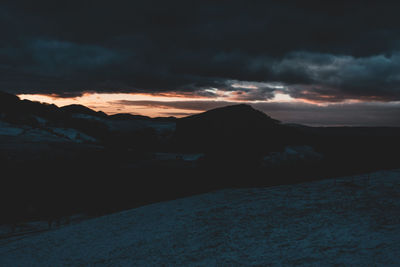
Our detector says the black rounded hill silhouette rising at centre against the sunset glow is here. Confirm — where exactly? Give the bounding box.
[176,104,287,153]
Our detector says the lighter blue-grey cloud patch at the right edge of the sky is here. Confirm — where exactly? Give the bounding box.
[275,52,400,101]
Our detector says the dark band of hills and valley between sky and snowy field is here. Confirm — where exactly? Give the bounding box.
[0,90,400,226]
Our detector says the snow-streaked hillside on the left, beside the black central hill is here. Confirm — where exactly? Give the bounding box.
[0,91,175,146]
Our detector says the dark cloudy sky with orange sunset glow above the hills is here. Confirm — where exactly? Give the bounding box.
[0,0,400,126]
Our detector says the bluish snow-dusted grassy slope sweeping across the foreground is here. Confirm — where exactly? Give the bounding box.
[0,170,400,266]
